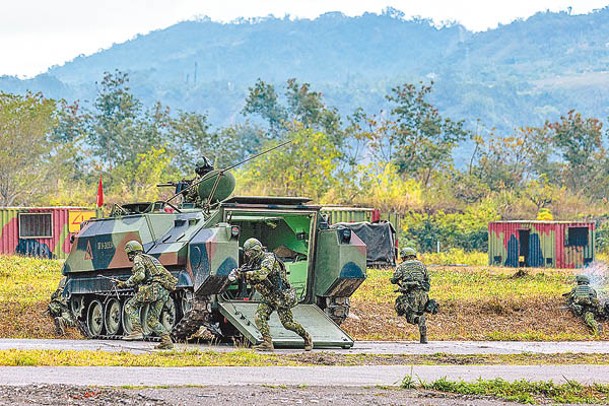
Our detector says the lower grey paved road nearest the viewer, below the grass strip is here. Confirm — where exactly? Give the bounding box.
[0,365,609,386]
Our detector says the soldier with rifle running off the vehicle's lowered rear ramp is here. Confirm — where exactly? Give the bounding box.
[229,238,313,351]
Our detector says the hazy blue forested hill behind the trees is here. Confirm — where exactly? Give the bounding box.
[0,8,609,131]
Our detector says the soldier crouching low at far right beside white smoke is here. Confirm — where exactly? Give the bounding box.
[563,275,604,335]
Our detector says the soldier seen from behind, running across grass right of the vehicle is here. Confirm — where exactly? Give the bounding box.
[391,248,435,344]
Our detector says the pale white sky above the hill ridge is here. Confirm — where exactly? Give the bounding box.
[0,0,609,77]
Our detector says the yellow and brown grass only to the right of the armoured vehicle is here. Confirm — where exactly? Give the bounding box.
[343,266,607,341]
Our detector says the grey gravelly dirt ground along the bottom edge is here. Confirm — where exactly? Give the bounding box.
[0,385,514,406]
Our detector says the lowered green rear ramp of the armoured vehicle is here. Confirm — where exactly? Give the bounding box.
[219,302,353,348]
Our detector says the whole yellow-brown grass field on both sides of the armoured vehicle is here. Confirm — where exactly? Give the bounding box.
[0,256,607,341]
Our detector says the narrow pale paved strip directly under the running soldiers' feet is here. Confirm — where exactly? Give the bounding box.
[0,339,609,354]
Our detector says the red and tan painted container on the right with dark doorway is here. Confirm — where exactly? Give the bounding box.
[488,220,595,268]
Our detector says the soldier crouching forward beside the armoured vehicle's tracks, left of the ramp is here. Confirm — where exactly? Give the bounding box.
[116,240,177,350]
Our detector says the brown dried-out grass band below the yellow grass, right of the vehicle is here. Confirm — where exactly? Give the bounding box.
[342,297,607,341]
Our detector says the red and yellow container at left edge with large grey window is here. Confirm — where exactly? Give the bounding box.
[0,207,102,259]
